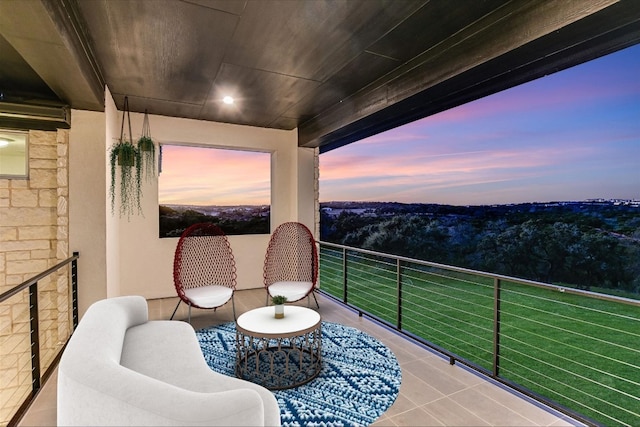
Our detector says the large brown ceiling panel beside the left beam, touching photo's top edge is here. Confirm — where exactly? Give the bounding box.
[79,0,238,104]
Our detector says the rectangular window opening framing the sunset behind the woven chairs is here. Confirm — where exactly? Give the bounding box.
[158,144,271,237]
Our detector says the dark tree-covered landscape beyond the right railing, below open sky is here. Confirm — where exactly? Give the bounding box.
[321,204,640,294]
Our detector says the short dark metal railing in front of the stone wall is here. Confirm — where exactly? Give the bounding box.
[0,252,80,426]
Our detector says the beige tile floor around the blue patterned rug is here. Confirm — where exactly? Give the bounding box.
[18,289,581,426]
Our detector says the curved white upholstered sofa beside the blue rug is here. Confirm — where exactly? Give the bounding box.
[57,296,280,426]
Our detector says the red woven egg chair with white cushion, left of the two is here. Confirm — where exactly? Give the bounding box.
[171,223,237,323]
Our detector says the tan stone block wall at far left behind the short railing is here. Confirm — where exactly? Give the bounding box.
[0,130,71,425]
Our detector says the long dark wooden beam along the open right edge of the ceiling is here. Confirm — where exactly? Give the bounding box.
[298,0,640,152]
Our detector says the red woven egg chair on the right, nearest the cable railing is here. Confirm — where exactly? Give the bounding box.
[264,222,320,308]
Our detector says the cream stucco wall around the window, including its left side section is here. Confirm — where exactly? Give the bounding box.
[70,91,317,314]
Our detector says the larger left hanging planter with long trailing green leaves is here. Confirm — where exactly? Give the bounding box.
[109,96,142,217]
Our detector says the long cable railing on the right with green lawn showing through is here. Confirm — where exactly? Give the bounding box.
[319,242,640,425]
